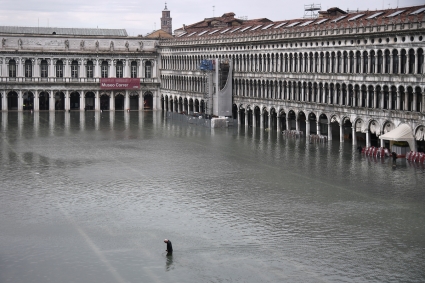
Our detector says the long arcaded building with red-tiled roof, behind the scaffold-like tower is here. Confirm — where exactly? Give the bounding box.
[159,6,425,150]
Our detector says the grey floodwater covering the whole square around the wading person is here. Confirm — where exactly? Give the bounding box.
[0,112,425,283]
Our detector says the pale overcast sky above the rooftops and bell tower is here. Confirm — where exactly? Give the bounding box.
[0,0,425,36]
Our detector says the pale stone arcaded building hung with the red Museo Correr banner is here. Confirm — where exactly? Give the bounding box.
[0,27,160,111]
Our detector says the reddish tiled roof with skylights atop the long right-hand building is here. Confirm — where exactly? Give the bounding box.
[170,5,425,40]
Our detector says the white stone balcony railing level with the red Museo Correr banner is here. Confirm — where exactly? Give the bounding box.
[0,77,159,84]
